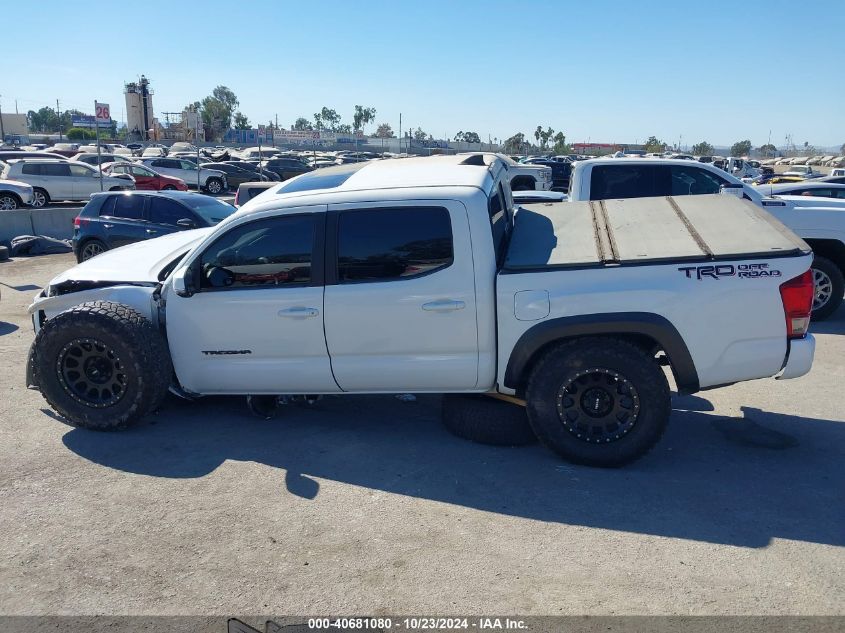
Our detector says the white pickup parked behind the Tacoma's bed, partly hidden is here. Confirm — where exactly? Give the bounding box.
[568,158,845,321]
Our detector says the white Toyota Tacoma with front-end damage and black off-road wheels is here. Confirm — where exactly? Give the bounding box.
[27,156,815,466]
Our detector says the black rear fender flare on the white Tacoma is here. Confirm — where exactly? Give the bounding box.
[504,312,700,393]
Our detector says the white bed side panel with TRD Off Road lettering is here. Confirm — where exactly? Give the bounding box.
[497,255,812,393]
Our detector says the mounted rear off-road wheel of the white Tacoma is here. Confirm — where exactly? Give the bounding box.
[526,337,671,467]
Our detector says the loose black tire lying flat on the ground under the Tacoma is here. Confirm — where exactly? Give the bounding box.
[442,394,537,446]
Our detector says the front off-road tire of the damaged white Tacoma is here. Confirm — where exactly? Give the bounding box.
[33,301,173,431]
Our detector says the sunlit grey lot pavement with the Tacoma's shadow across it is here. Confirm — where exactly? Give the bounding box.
[0,255,845,615]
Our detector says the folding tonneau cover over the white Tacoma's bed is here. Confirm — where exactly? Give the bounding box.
[504,194,810,270]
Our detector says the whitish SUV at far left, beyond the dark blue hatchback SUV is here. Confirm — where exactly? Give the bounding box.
[2,159,135,208]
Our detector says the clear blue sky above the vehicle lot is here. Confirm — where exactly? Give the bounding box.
[0,0,845,148]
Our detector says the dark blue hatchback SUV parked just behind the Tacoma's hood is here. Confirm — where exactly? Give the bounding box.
[73,191,235,262]
